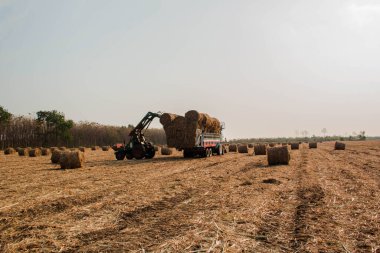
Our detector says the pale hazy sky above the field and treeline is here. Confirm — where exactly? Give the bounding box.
[0,0,380,139]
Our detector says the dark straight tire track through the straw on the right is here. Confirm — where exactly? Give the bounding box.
[291,148,343,252]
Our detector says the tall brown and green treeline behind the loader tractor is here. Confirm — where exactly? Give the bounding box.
[0,106,166,149]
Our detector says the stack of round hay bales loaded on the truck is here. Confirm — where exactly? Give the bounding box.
[160,110,221,148]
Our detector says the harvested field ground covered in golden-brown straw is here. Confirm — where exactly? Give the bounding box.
[0,141,380,253]
